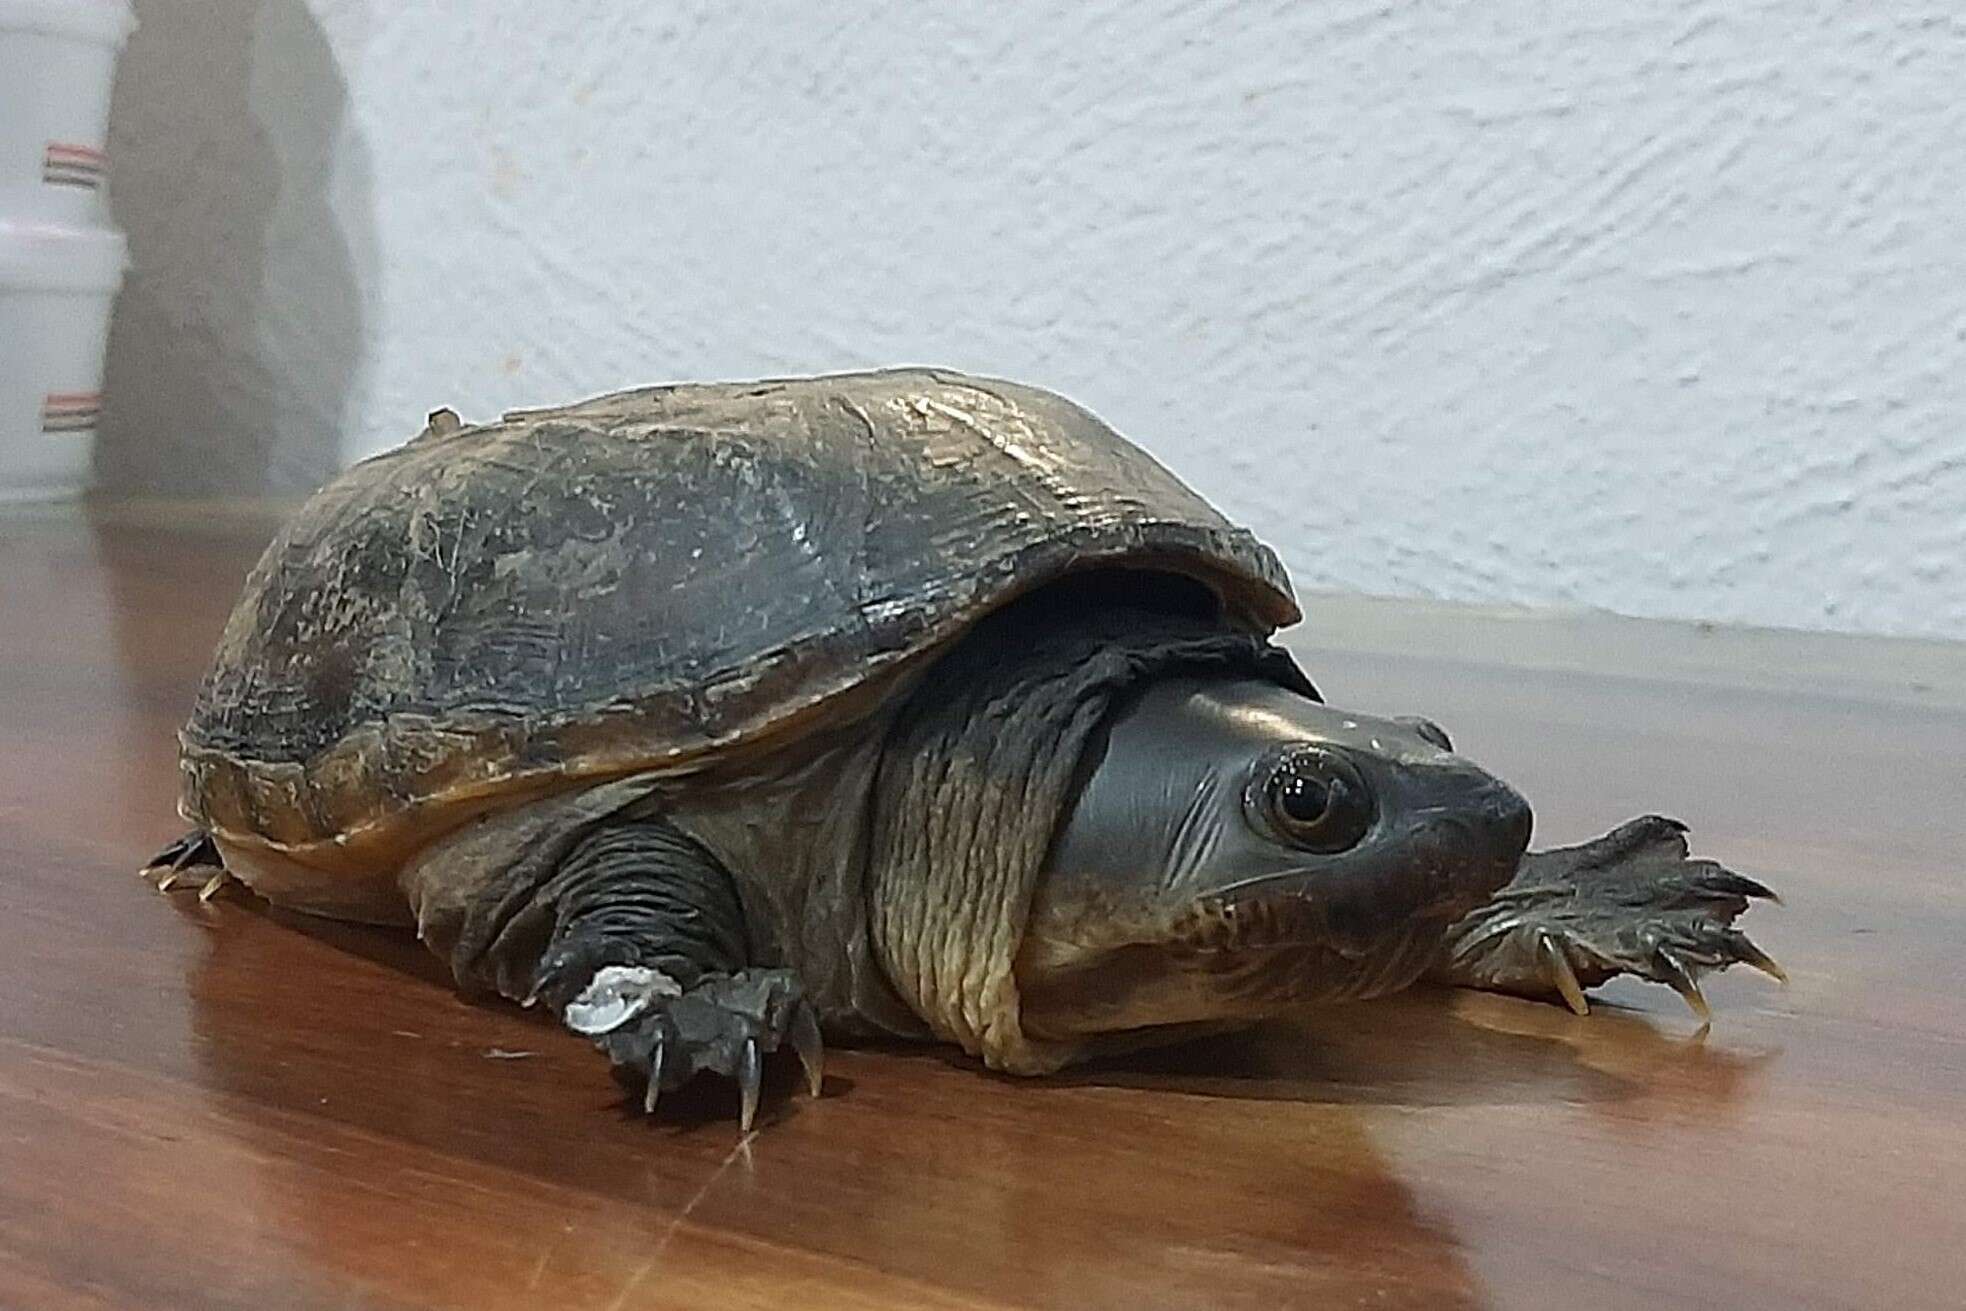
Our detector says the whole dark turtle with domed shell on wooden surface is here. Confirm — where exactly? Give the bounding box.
[144,368,1781,1132]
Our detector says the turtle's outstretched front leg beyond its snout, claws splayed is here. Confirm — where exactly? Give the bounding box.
[1429,816,1787,1022]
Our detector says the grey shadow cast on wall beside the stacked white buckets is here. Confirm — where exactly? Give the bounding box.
[96,0,374,495]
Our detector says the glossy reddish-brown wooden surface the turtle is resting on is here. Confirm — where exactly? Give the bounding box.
[0,511,1966,1309]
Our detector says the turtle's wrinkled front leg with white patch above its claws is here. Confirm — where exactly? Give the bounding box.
[490,820,822,1132]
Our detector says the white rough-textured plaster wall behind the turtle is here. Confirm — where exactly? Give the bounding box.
[104,0,1966,637]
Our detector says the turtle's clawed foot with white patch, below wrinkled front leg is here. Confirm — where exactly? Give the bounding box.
[560,965,824,1132]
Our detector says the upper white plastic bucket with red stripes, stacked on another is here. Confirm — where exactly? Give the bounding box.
[0,0,136,226]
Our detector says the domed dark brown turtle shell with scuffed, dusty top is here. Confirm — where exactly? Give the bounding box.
[181,370,1298,869]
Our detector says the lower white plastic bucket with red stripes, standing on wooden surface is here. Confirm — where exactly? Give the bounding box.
[0,220,126,501]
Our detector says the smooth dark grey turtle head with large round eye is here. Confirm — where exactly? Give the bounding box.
[1016,678,1530,1044]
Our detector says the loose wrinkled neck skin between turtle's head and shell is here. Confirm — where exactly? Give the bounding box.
[867,592,1309,1073]
